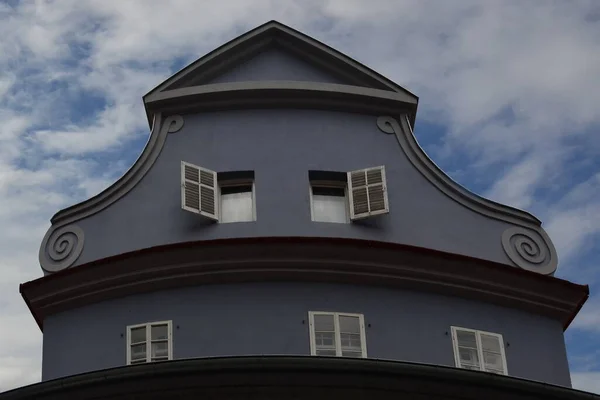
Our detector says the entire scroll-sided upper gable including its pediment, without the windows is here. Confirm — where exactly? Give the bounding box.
[40,23,557,282]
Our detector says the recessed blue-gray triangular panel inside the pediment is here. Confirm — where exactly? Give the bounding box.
[206,45,352,85]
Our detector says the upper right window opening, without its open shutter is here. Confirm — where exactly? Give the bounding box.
[310,182,350,223]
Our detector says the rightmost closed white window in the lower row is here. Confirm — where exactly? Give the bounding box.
[452,326,507,375]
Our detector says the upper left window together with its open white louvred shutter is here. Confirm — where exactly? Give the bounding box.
[181,162,256,223]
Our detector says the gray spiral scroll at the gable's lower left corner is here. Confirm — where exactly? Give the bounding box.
[40,225,84,272]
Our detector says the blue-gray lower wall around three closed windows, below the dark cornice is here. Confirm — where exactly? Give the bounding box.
[42,282,570,386]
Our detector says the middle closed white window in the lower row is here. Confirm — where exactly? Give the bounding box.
[308,311,367,358]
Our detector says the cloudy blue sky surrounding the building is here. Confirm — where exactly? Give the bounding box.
[0,0,600,393]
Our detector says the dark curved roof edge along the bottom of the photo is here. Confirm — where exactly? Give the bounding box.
[0,356,600,400]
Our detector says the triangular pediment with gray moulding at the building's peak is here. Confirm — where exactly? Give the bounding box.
[144,21,416,102]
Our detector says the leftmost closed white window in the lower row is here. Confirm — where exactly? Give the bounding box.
[127,321,173,365]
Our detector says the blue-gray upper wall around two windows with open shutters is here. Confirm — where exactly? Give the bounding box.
[75,109,512,265]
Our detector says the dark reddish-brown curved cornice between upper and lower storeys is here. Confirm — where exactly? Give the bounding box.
[20,237,589,329]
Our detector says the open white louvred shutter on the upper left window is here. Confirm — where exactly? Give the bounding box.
[181,161,219,221]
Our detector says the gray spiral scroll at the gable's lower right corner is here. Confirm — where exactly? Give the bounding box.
[502,226,558,275]
